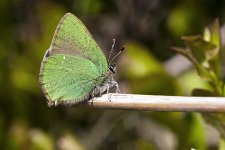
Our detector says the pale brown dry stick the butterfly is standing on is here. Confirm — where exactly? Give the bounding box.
[87,93,225,112]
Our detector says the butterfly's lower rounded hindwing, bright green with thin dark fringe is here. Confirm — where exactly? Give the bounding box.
[42,54,103,105]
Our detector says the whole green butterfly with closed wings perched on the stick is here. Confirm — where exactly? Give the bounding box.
[39,13,119,106]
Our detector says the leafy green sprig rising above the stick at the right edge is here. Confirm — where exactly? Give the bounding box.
[172,19,224,96]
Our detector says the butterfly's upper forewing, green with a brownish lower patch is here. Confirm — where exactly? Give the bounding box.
[50,13,108,74]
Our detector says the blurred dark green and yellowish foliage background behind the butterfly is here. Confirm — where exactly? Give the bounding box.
[0,0,225,150]
